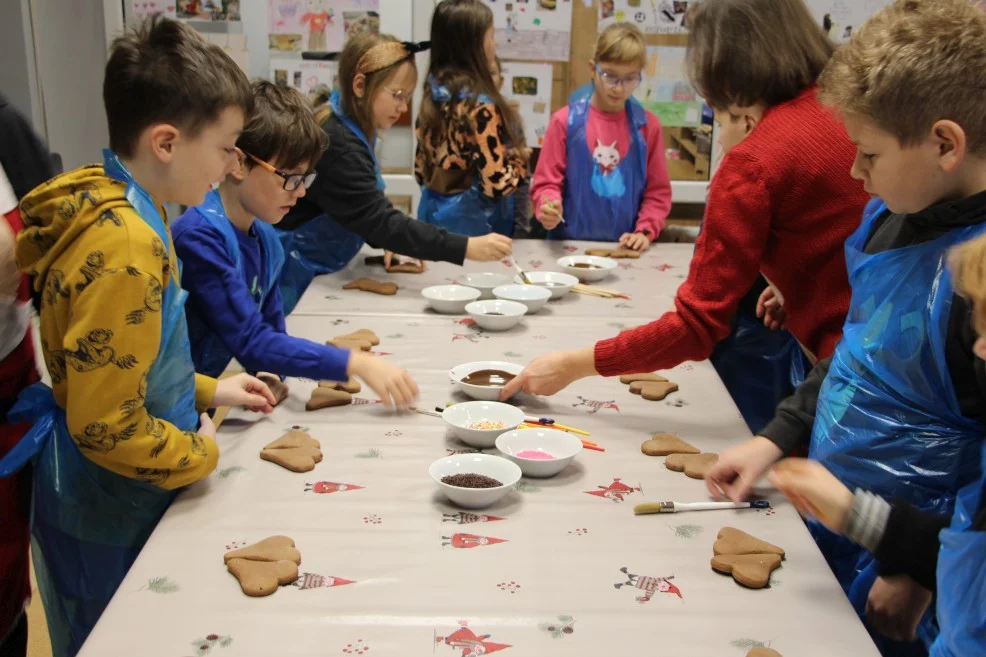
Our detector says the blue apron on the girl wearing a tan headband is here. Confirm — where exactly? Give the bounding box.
[277,89,384,315]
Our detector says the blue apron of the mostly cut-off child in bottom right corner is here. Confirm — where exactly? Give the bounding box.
[931,436,986,657]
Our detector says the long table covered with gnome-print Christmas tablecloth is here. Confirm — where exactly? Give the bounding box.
[81,242,878,657]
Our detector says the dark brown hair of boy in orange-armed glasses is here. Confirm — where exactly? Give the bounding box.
[236,80,329,169]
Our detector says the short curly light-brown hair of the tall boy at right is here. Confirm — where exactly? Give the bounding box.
[819,0,986,155]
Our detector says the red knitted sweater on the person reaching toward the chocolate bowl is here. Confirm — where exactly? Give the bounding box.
[595,87,869,376]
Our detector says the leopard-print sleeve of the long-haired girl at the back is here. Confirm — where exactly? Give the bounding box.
[468,103,527,198]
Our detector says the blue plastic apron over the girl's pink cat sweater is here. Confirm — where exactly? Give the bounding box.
[548,84,647,242]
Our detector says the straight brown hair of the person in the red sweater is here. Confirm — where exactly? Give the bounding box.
[686,0,835,110]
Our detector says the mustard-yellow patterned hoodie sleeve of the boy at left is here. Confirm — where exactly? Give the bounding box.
[63,267,219,489]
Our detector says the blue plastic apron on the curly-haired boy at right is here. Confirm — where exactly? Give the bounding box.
[810,200,986,654]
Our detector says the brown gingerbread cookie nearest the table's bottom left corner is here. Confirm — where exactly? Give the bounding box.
[223,536,301,598]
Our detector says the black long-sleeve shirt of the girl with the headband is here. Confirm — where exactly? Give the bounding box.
[277,116,469,265]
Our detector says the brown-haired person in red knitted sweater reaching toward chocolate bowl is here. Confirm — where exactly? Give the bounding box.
[504,0,869,398]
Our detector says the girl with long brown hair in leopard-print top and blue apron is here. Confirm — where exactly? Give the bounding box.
[414,0,529,235]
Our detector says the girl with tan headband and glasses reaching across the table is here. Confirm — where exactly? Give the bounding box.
[277,33,512,314]
